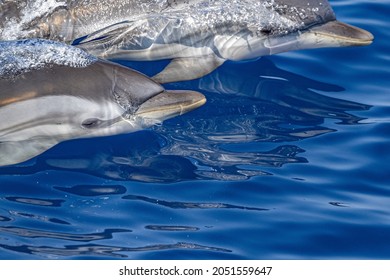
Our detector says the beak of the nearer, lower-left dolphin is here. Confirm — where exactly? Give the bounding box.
[135,90,206,121]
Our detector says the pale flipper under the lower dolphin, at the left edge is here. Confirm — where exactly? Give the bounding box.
[0,138,58,166]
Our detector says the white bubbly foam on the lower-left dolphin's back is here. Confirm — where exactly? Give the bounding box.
[0,39,97,78]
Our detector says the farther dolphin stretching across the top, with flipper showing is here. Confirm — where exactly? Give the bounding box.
[0,0,373,82]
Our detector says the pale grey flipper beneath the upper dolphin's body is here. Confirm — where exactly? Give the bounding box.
[152,55,225,84]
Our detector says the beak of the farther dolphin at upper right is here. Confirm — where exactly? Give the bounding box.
[309,20,374,46]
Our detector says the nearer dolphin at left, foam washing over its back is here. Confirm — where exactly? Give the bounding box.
[0,39,205,166]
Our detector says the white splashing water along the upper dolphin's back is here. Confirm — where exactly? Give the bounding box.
[0,0,330,40]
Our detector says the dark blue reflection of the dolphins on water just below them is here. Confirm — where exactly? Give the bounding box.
[0,58,370,183]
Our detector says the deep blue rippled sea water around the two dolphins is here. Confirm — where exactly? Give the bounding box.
[0,0,390,259]
